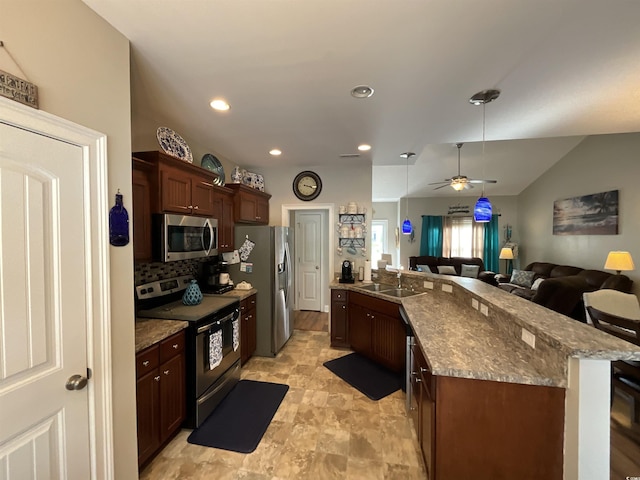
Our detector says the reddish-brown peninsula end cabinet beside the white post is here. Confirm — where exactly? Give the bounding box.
[411,340,565,480]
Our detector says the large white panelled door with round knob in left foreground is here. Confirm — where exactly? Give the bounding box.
[0,105,110,480]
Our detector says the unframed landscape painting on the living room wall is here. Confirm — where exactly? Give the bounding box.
[553,190,618,235]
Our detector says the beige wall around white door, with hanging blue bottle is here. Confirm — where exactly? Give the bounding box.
[0,0,137,479]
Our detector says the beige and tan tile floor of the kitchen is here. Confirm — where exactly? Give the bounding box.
[140,330,426,480]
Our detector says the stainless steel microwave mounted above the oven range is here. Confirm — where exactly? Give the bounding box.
[153,213,218,262]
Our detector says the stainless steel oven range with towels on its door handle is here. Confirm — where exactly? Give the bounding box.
[136,276,240,428]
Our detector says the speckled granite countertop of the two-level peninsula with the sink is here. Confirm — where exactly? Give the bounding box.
[330,272,640,387]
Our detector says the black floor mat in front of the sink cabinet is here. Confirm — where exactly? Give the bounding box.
[324,353,403,400]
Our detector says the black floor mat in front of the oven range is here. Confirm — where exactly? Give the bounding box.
[187,380,289,453]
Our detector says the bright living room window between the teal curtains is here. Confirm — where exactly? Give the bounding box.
[442,217,484,258]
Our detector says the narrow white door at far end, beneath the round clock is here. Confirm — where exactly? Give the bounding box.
[295,211,324,312]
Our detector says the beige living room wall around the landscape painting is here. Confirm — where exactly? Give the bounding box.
[518,133,640,293]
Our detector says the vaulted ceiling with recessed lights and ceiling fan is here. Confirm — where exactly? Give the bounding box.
[84,0,640,200]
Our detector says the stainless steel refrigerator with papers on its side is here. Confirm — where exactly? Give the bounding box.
[229,225,294,357]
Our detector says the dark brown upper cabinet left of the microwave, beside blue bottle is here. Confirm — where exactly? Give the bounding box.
[131,158,154,262]
